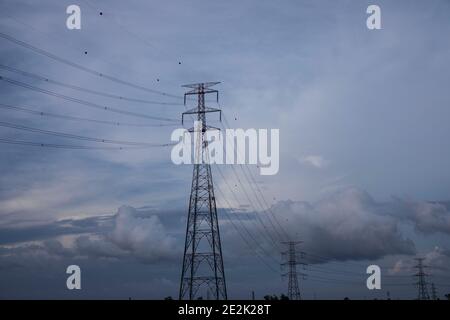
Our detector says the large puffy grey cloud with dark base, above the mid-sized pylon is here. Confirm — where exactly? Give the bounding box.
[266,188,415,260]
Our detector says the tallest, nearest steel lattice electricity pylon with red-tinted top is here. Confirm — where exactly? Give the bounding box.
[179,82,227,300]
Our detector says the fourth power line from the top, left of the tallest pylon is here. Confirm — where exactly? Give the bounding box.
[0,103,177,127]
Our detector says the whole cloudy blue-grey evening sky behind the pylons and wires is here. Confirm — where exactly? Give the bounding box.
[0,0,450,299]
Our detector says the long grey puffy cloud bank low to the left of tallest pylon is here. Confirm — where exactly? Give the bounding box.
[0,206,178,268]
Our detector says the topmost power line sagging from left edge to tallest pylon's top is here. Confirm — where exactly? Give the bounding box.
[0,32,181,98]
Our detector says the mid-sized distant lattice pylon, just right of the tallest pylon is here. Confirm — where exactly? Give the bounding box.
[281,241,306,300]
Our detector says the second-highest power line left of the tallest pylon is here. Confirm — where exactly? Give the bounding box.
[0,64,183,106]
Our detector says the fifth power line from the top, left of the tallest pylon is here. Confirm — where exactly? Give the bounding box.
[0,121,172,147]
